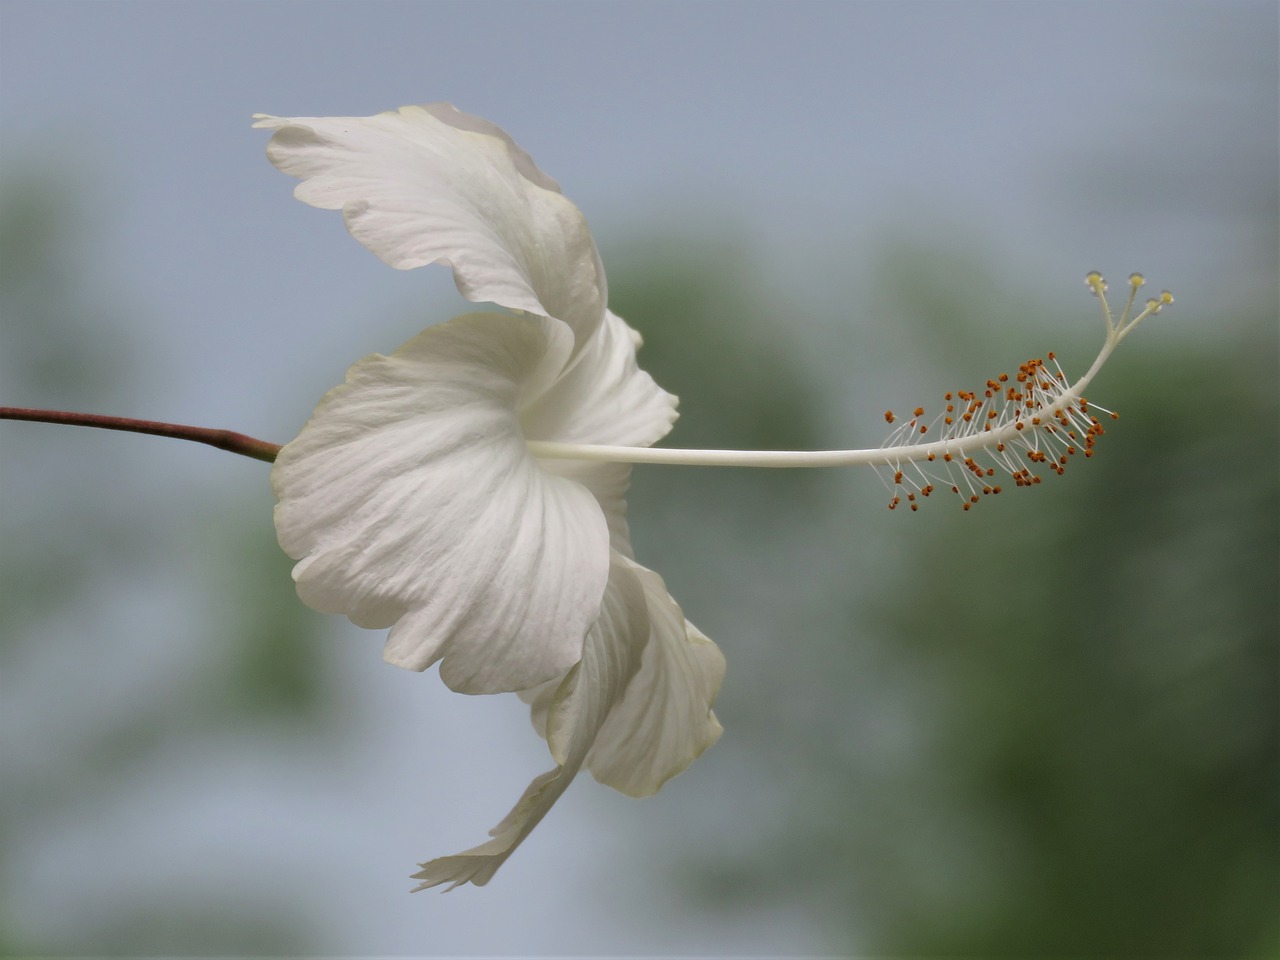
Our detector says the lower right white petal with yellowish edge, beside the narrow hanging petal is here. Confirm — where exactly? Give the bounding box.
[586,557,724,796]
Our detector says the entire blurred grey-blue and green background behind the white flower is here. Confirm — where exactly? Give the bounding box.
[0,0,1280,957]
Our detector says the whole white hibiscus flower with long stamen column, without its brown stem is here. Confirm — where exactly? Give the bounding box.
[252,104,1172,888]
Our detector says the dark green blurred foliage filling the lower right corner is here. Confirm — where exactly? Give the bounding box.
[874,289,1280,956]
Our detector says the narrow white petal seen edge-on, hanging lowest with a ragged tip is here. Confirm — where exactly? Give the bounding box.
[413,554,649,891]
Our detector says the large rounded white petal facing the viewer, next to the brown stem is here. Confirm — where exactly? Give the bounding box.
[271,314,609,694]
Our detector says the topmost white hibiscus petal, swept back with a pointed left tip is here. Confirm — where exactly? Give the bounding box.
[255,104,608,343]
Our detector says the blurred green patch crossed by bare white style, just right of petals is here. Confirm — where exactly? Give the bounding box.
[609,236,829,601]
